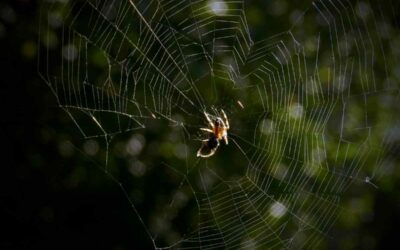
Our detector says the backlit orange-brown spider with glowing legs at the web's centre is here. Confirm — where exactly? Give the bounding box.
[197,109,229,158]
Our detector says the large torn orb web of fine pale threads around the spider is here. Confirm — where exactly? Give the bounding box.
[39,0,400,249]
